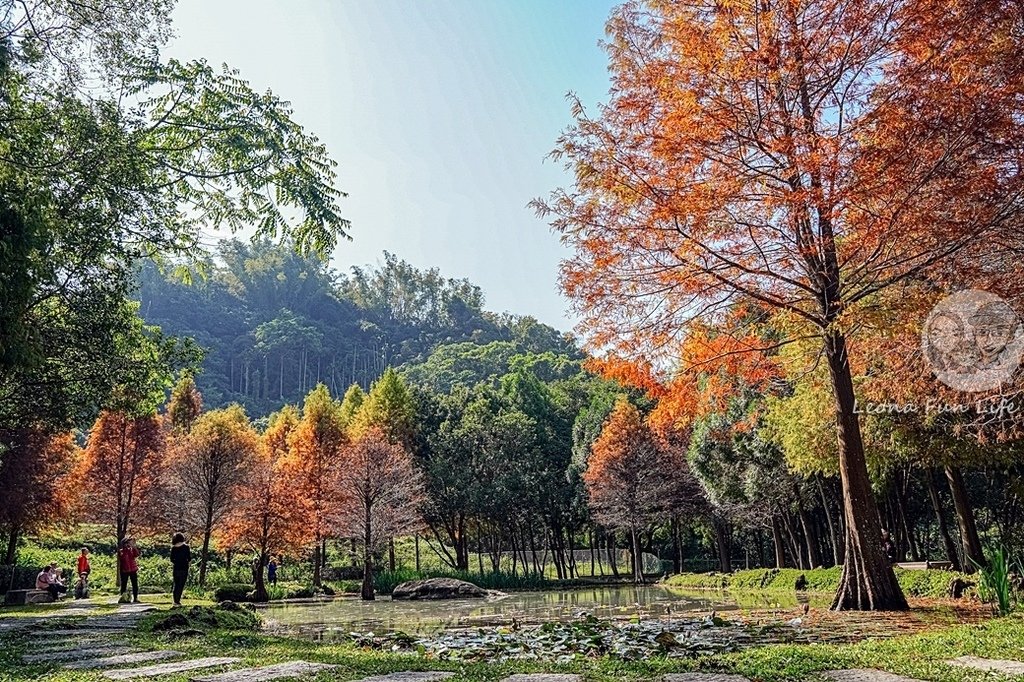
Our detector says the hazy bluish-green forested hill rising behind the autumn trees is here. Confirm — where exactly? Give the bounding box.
[138,240,582,417]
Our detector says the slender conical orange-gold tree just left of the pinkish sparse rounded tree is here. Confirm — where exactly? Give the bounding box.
[281,384,348,586]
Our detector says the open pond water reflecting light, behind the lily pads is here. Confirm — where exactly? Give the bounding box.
[253,586,790,639]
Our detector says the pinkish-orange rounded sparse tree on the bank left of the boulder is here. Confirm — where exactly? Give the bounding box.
[339,426,424,600]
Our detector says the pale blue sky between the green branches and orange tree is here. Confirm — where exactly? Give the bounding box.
[169,0,615,331]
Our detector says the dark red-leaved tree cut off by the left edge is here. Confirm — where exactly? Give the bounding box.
[0,427,79,565]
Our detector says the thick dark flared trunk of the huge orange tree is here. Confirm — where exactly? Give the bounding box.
[825,331,907,610]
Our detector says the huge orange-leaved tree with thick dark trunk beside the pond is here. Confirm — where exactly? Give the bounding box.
[536,0,1024,609]
